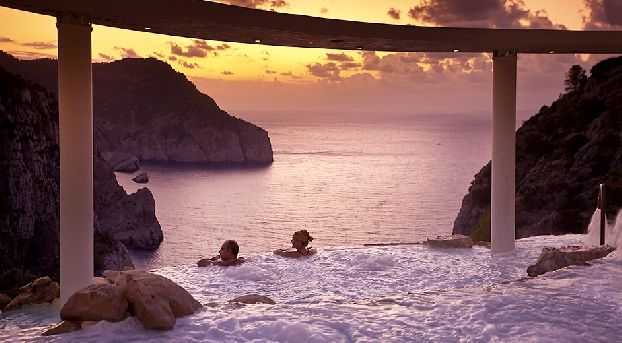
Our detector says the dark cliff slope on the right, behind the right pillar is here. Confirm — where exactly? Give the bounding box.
[453,57,622,237]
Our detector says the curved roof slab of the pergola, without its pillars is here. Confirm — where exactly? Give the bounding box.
[0,0,622,54]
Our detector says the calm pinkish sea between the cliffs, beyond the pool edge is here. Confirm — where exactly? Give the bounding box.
[117,111,528,269]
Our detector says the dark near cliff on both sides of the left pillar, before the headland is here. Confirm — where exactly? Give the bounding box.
[0,68,162,275]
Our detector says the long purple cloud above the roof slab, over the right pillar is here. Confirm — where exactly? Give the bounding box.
[408,0,566,29]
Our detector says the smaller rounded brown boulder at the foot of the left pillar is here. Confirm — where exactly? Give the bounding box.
[60,279,128,322]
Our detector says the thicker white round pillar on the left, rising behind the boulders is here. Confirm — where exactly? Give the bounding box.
[56,16,93,306]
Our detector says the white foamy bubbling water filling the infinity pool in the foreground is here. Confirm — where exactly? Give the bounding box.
[0,235,622,342]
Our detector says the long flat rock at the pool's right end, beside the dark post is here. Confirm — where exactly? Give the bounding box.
[527,245,615,276]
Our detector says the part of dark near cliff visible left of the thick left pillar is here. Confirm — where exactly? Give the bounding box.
[0,69,60,273]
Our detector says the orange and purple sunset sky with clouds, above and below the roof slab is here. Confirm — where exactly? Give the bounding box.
[0,0,622,114]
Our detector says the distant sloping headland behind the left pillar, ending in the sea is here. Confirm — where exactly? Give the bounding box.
[0,52,273,163]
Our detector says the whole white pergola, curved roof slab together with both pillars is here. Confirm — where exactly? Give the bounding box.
[0,0,622,303]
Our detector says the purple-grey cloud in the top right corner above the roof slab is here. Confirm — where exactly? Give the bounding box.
[583,0,622,30]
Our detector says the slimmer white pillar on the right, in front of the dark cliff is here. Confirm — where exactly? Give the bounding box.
[490,51,517,253]
